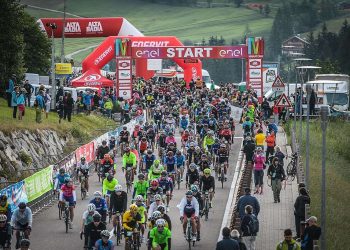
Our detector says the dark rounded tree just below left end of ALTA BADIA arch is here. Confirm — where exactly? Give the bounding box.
[23,13,51,74]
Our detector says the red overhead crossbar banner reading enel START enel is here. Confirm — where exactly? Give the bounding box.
[131,45,247,59]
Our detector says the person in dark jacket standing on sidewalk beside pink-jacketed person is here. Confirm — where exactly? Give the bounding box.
[267,157,286,203]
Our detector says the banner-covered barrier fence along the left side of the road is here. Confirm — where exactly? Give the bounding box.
[0,115,145,214]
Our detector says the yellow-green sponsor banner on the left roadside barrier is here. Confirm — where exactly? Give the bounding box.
[24,166,53,202]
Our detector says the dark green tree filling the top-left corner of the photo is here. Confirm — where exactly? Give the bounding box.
[0,0,24,89]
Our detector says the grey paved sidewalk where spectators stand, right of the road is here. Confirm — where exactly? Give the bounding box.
[252,127,298,250]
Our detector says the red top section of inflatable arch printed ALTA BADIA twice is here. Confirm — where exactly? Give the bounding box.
[38,17,123,38]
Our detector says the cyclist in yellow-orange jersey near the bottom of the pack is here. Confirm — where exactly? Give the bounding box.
[123,204,142,245]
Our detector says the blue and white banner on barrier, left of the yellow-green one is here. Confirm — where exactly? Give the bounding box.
[0,181,28,211]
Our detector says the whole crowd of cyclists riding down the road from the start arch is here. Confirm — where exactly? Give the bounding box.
[0,79,246,250]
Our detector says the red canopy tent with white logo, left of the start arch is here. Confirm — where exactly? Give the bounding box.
[72,70,114,88]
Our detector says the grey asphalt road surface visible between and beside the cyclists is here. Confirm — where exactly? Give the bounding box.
[30,128,242,250]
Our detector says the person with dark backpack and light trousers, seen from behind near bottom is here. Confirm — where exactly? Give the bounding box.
[241,205,259,250]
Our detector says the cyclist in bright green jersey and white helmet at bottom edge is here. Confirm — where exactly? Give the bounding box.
[150,219,171,250]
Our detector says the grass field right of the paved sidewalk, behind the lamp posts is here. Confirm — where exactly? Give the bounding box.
[286,121,350,250]
